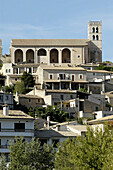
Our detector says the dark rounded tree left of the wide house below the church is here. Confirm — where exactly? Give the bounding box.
[21,72,35,88]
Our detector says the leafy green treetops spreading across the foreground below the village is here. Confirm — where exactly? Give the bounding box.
[0,126,113,170]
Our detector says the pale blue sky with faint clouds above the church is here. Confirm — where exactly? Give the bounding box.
[0,0,113,62]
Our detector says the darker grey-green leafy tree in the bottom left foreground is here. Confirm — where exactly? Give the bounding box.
[9,137,55,170]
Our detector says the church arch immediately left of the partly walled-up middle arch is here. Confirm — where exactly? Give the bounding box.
[26,49,34,63]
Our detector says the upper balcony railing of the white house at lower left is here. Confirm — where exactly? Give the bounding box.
[0,128,34,133]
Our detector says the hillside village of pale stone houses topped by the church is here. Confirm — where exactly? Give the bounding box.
[0,21,113,160]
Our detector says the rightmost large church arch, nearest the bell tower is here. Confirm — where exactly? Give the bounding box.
[62,48,71,63]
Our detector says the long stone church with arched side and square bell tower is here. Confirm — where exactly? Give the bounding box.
[10,21,102,66]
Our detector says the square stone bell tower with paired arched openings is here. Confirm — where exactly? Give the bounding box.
[88,21,102,62]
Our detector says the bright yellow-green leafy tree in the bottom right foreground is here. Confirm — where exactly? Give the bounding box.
[55,126,113,170]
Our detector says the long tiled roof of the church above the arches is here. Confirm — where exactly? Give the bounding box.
[11,39,89,47]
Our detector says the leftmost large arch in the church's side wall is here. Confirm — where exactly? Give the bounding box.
[15,49,23,63]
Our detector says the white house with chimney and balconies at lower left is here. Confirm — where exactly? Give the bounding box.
[0,105,34,160]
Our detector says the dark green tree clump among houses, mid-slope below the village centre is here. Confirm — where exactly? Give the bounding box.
[35,106,67,122]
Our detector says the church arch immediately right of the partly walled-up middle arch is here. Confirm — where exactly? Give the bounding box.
[50,49,58,63]
